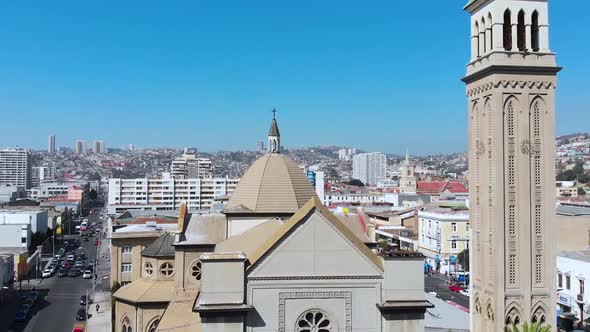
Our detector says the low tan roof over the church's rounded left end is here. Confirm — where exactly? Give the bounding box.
[113,278,176,303]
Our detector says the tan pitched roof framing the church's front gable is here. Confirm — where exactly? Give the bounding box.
[220,197,383,271]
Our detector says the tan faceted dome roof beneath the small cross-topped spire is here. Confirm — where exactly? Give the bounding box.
[225,153,316,214]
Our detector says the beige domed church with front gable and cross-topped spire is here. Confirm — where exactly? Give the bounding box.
[113,116,433,332]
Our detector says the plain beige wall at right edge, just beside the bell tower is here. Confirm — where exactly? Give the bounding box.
[555,215,590,251]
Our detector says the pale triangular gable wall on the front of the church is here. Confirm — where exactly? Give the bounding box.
[249,210,382,277]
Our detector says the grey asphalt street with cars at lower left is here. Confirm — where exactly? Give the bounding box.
[7,213,100,332]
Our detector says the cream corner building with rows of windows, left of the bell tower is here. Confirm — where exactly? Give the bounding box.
[418,203,471,273]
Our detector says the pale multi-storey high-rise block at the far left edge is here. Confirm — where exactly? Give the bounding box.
[0,148,32,189]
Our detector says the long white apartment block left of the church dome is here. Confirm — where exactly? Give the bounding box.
[108,173,240,214]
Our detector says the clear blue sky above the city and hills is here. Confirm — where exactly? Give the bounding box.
[0,0,590,154]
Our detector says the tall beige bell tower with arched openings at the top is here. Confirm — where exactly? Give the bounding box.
[463,0,560,331]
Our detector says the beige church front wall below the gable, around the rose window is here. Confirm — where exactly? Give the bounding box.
[247,280,381,332]
